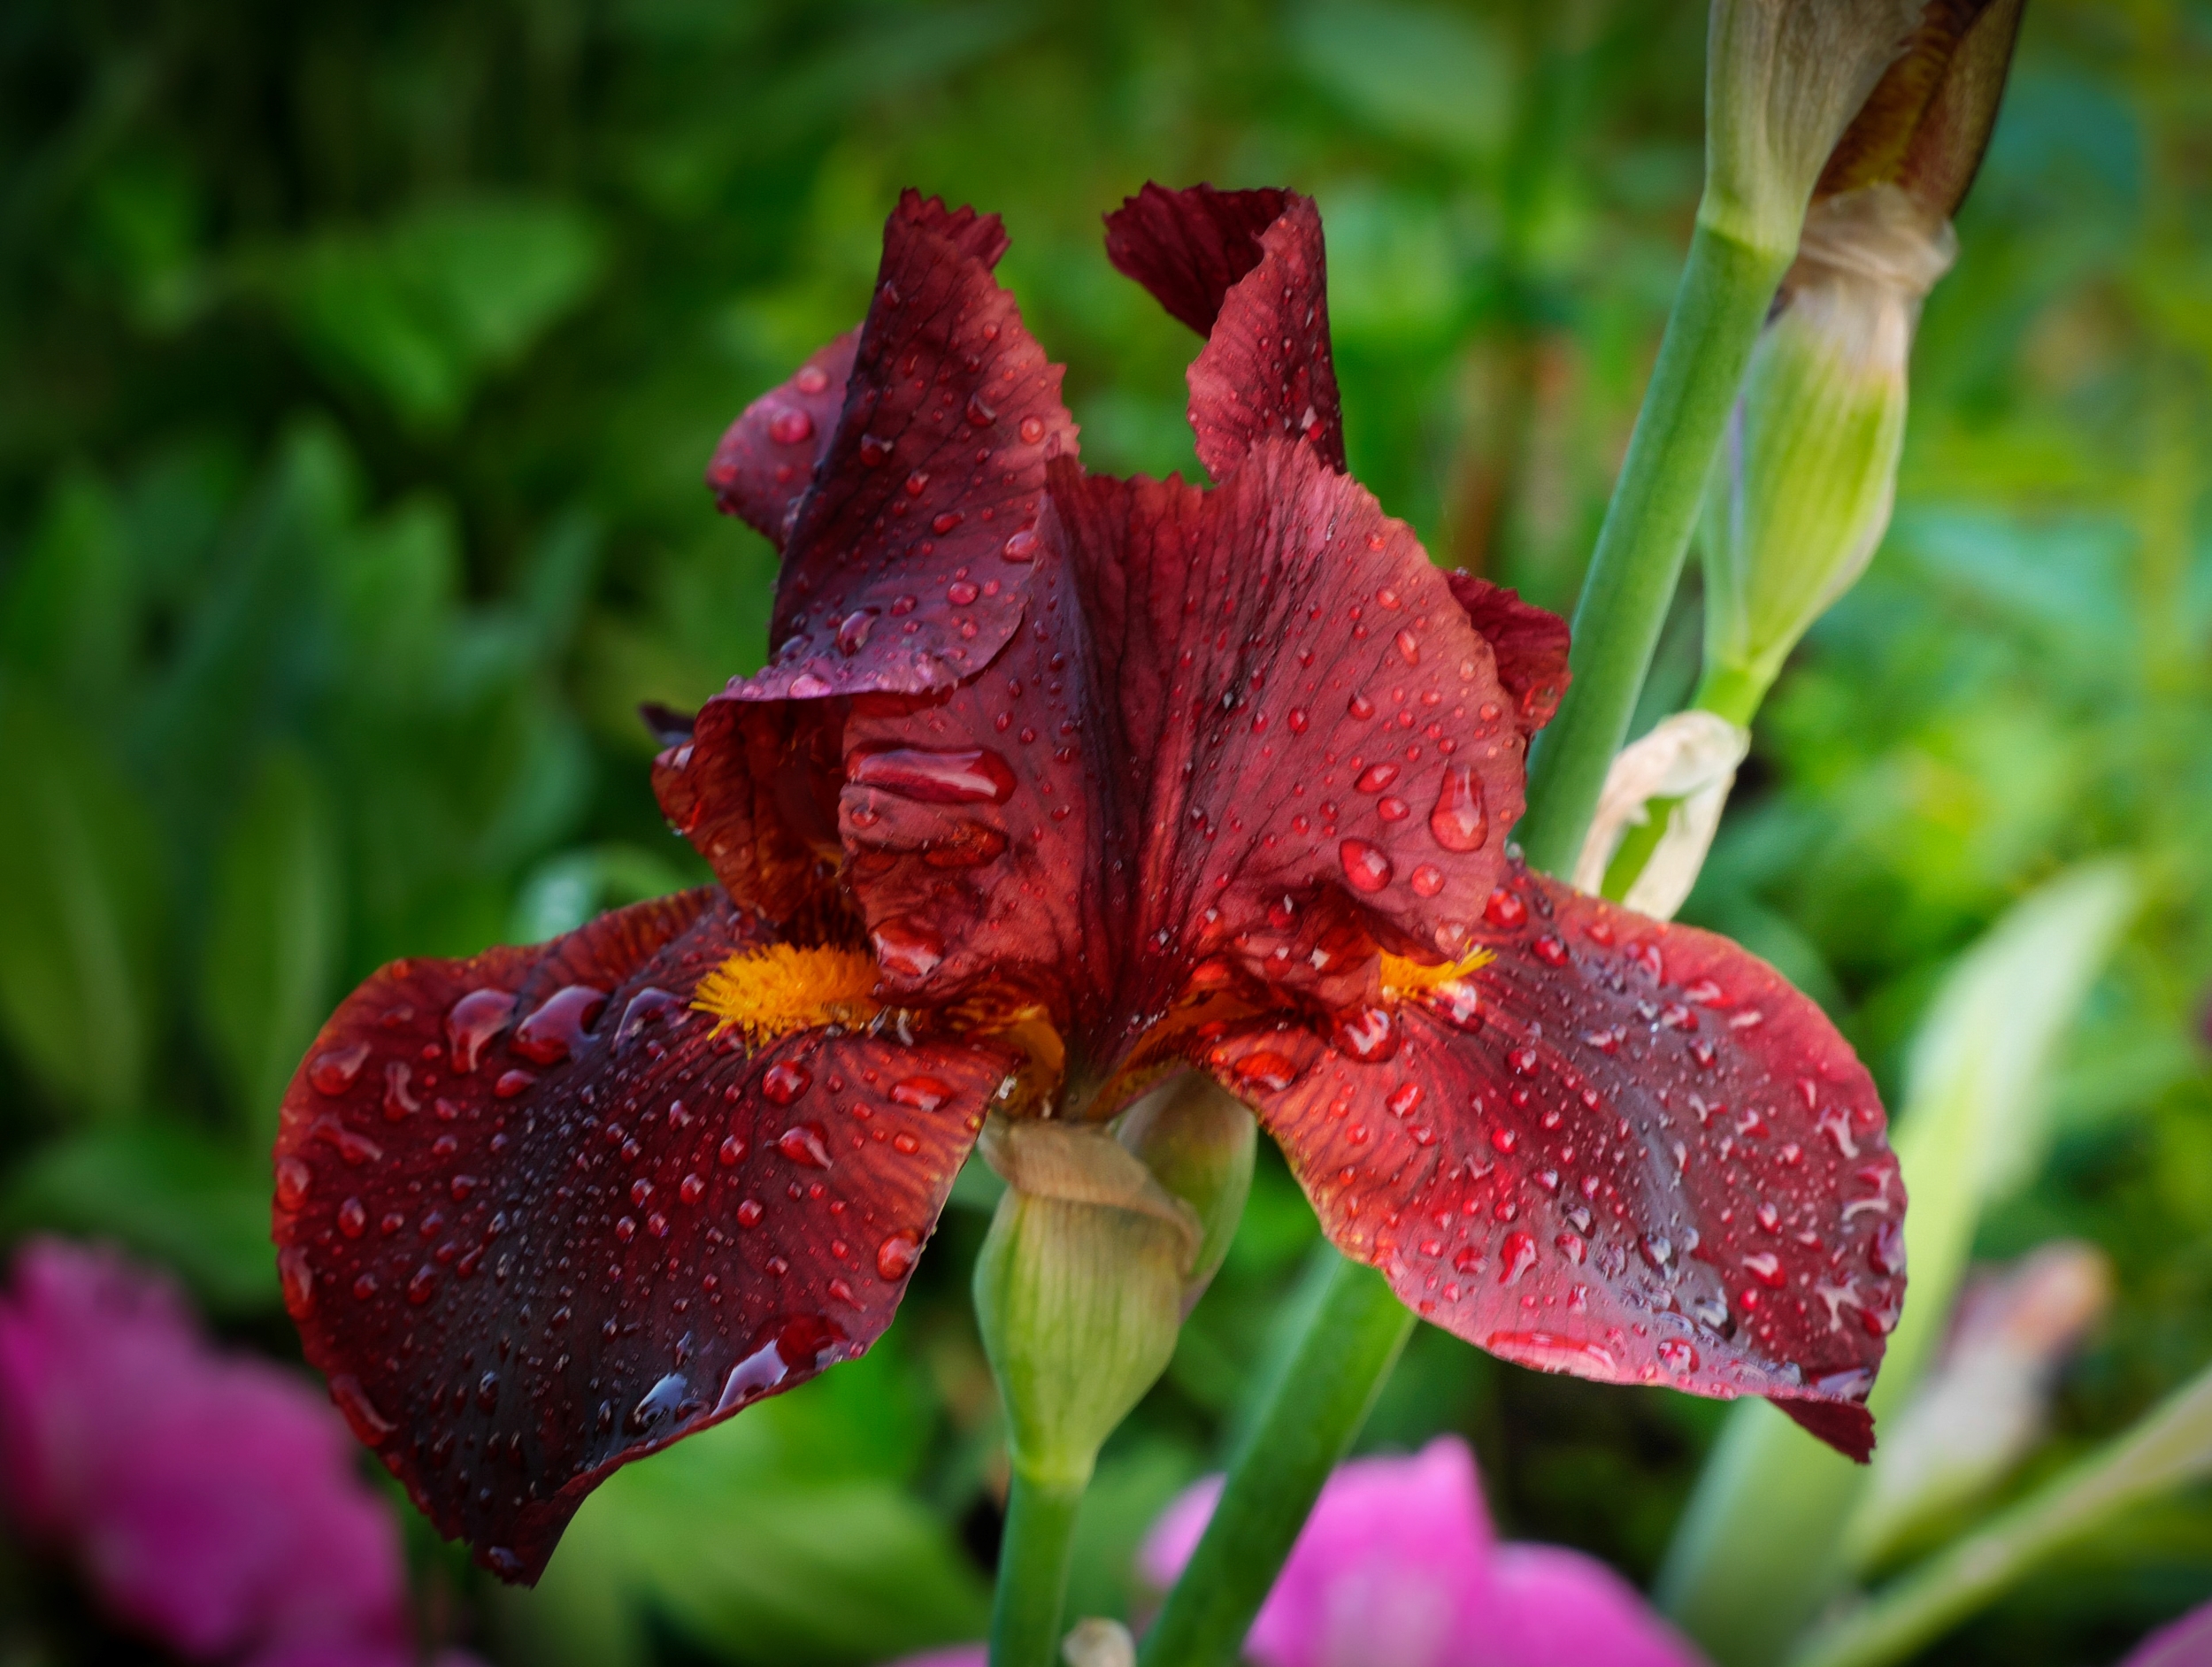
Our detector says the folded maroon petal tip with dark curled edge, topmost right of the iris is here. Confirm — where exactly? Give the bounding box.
[1106,186,1345,480]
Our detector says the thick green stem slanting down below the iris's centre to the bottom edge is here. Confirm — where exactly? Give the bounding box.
[1141,1256,1414,1667]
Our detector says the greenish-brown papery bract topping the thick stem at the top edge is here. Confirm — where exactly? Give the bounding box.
[1697,0,1923,252]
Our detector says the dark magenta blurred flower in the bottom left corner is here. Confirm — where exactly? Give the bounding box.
[0,1241,467,1667]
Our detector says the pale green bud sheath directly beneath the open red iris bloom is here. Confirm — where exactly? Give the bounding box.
[976,1077,1256,1486]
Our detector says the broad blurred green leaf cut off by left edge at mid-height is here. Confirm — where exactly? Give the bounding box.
[0,686,166,1117]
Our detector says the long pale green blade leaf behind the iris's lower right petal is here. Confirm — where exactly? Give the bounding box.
[1659,860,2137,1667]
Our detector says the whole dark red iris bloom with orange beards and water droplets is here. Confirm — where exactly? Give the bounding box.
[277,186,1905,1579]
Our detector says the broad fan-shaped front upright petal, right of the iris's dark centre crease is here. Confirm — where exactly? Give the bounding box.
[1056,440,1525,1010]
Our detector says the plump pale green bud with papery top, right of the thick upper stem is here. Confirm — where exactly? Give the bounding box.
[1699,186,1954,703]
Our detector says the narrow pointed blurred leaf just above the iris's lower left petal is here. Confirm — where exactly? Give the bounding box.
[199,748,345,1145]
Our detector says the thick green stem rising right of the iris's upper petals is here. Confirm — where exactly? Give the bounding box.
[1516,223,1792,873]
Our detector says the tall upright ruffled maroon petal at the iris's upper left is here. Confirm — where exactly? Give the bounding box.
[733,190,1075,701]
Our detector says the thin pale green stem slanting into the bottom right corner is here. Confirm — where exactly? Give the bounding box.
[1790,1371,2212,1667]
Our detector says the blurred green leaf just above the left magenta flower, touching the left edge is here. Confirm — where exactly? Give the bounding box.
[0,1123,277,1316]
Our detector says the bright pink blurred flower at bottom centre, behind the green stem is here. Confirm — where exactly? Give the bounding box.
[1137,1435,1699,1667]
